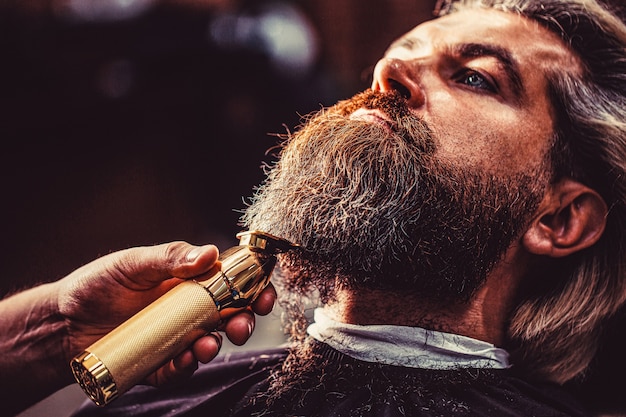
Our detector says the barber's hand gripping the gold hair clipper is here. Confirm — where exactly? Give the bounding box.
[58,242,276,385]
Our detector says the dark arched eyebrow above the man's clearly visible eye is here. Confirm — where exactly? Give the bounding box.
[453,43,525,101]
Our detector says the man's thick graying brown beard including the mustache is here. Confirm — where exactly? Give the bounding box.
[242,91,547,302]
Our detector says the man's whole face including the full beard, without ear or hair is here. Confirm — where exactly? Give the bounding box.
[244,11,571,300]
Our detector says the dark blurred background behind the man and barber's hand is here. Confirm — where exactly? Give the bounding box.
[0,0,626,416]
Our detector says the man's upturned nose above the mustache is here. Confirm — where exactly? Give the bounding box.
[372,58,426,108]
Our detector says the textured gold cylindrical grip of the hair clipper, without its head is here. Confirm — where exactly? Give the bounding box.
[71,281,220,405]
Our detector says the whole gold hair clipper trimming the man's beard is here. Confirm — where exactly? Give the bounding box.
[70,231,298,406]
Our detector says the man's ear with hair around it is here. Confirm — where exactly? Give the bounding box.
[522,178,608,257]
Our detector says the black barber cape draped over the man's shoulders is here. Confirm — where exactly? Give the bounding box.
[75,342,587,417]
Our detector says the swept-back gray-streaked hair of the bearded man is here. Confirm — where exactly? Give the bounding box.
[439,0,626,383]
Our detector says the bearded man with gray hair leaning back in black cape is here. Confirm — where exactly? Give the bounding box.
[73,0,626,417]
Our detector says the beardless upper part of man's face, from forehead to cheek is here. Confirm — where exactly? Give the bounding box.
[372,9,577,174]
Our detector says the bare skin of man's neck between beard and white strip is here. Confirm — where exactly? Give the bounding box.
[316,245,529,346]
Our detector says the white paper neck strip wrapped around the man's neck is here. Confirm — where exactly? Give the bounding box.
[307,308,509,369]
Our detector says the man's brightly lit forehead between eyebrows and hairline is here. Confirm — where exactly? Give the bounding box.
[389,8,581,76]
